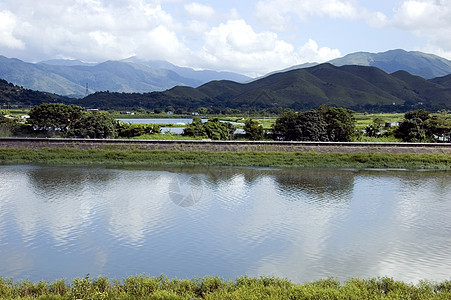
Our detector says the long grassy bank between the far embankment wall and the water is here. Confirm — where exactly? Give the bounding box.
[0,148,451,169]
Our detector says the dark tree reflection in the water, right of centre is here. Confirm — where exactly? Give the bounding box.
[274,169,355,203]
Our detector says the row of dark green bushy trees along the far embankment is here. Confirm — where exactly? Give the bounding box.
[0,103,451,142]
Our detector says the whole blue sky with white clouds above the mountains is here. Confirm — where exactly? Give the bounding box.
[0,0,451,76]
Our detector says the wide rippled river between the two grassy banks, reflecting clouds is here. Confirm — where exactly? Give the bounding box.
[0,166,451,282]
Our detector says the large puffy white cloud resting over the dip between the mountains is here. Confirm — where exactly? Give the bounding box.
[198,20,340,76]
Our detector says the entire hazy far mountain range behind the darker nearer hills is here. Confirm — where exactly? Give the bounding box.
[0,50,451,98]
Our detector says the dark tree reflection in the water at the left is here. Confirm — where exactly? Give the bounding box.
[27,167,115,198]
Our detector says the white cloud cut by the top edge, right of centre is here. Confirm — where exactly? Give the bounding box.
[255,0,359,30]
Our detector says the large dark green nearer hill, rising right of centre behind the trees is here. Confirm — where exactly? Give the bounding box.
[76,64,451,111]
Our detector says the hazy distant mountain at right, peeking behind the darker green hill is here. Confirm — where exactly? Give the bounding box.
[266,49,451,79]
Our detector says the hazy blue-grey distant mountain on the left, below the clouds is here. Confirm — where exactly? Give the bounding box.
[0,56,249,97]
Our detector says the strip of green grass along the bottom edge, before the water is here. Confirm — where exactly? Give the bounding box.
[0,275,451,300]
